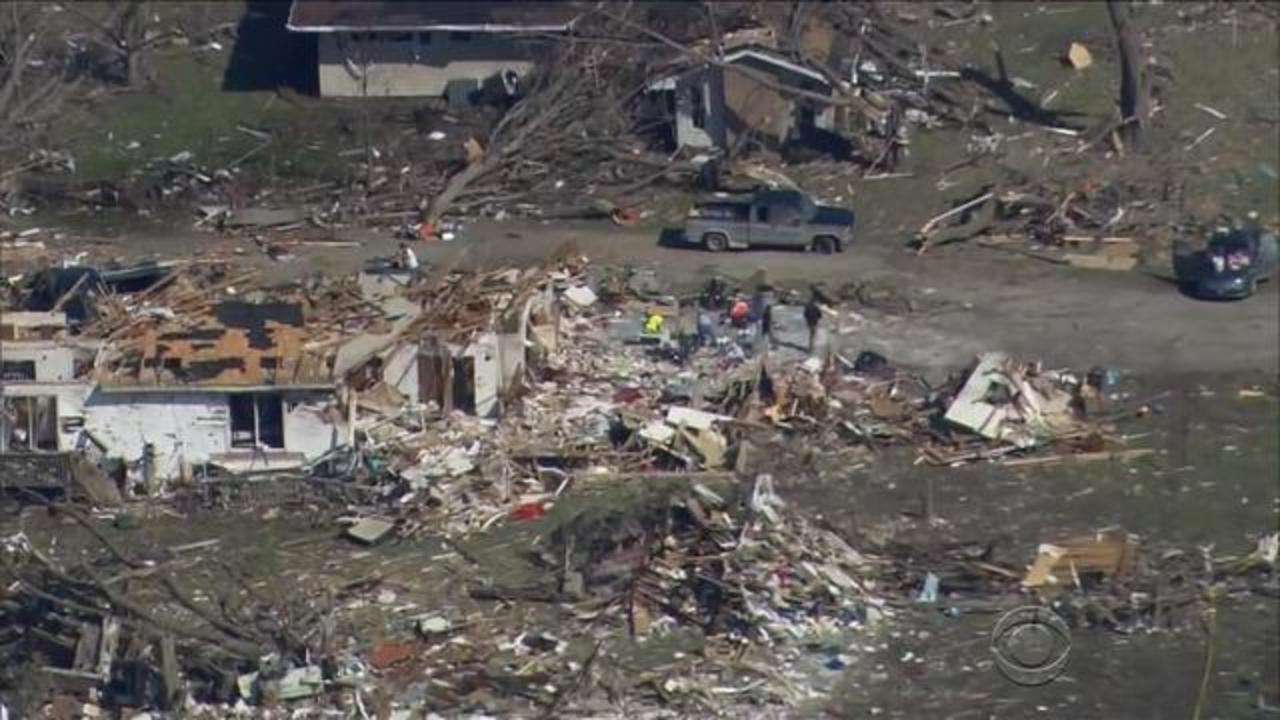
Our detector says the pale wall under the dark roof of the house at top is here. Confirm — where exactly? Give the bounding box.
[316,32,532,97]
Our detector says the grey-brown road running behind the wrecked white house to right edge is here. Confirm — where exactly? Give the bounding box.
[241,222,1280,375]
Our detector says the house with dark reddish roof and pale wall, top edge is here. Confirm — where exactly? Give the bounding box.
[288,0,581,102]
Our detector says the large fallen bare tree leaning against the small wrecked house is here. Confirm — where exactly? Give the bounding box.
[421,4,880,225]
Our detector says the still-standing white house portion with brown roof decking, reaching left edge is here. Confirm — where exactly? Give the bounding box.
[0,297,340,480]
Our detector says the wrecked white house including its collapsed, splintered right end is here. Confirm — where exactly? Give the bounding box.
[0,257,559,488]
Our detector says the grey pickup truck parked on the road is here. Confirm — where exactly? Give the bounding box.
[685,191,854,255]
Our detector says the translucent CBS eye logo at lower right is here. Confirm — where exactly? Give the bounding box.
[991,605,1071,687]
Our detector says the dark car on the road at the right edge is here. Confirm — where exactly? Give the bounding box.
[1174,228,1277,300]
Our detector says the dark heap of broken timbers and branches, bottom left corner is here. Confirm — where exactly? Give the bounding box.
[0,506,321,711]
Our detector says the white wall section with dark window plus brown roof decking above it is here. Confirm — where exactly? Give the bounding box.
[84,301,342,478]
